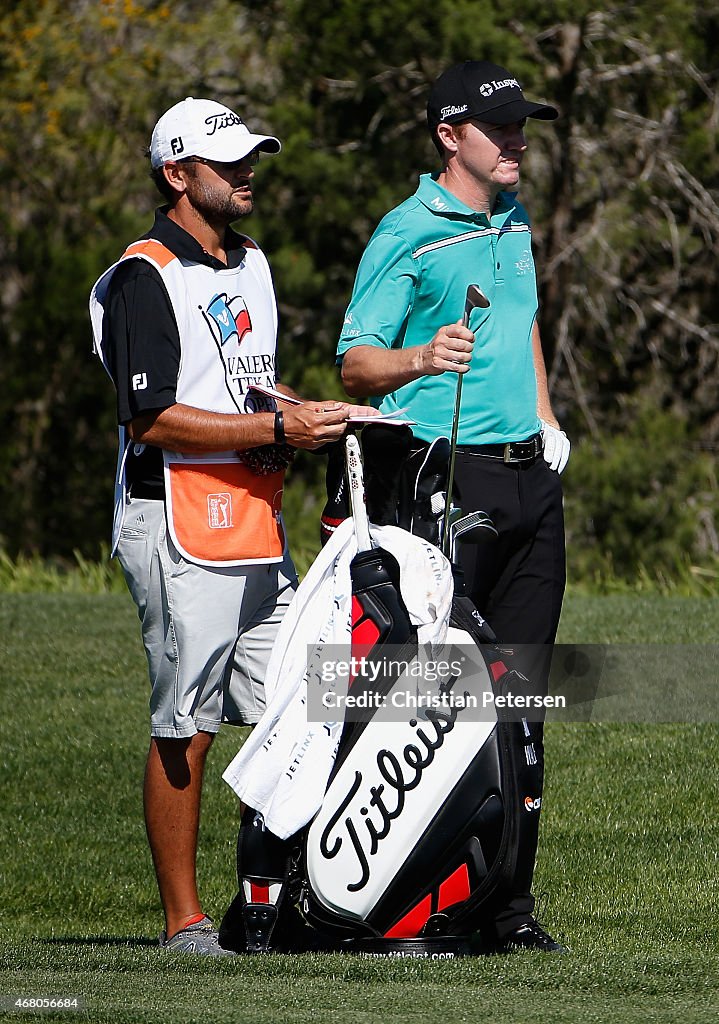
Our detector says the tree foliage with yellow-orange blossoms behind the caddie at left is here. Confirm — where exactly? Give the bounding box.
[0,0,274,556]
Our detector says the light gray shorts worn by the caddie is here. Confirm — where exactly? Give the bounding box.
[118,499,297,738]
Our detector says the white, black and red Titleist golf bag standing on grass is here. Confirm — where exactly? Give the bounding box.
[220,437,542,957]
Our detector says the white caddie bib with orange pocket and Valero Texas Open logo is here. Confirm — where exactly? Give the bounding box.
[90,239,286,566]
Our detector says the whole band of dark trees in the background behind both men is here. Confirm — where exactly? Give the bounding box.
[0,0,719,585]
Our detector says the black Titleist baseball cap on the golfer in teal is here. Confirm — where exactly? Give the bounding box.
[427,60,559,129]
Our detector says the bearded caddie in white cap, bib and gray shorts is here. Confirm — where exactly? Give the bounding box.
[90,97,366,956]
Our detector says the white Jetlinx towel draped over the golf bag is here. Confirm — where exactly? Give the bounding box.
[222,518,453,839]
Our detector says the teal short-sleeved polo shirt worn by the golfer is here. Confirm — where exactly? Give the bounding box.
[337,174,540,444]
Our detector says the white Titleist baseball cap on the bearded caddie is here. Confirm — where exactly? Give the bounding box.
[150,96,282,167]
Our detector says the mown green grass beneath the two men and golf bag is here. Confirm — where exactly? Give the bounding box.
[0,593,719,1024]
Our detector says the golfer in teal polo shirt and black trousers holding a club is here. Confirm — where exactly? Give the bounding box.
[337,60,569,952]
